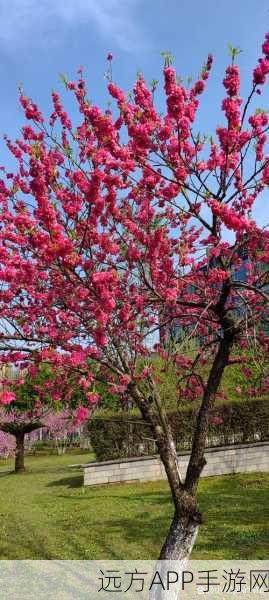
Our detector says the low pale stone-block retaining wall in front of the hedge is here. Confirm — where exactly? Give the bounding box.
[81,442,269,485]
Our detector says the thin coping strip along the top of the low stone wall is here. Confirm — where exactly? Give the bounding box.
[70,440,269,469]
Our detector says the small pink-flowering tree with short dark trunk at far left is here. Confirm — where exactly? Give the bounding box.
[0,365,89,473]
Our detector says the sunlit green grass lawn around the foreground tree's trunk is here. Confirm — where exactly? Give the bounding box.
[0,454,269,559]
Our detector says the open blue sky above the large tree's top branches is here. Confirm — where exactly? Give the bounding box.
[0,0,269,225]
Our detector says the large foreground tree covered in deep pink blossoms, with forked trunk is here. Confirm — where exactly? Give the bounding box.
[0,34,269,559]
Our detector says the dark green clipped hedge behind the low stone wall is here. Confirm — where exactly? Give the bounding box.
[88,399,269,461]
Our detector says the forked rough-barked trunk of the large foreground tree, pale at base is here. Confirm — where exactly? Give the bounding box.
[130,316,236,561]
